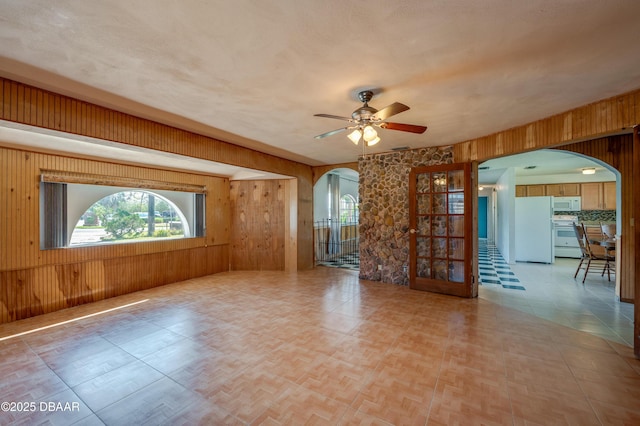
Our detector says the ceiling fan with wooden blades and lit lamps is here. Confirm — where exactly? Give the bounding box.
[314,90,427,146]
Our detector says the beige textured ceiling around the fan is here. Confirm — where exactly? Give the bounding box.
[0,0,640,165]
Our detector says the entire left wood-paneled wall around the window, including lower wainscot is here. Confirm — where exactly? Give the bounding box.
[0,147,230,323]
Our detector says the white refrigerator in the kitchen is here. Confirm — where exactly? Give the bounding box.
[515,197,555,263]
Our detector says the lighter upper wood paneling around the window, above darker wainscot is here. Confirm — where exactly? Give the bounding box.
[0,148,229,270]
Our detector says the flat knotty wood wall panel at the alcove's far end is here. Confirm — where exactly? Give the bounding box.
[230,180,289,271]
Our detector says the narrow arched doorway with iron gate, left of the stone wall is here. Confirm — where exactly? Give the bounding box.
[313,168,360,269]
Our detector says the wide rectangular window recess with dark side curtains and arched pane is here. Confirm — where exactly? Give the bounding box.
[40,177,205,249]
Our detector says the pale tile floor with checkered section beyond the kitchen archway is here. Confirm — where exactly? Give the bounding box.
[478,240,633,346]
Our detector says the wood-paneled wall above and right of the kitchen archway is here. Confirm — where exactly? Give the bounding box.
[453,90,640,302]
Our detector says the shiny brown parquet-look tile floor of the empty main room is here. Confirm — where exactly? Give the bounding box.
[0,265,640,426]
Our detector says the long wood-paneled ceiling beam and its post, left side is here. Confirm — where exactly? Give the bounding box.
[0,78,313,270]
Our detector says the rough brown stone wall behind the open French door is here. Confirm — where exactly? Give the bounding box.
[358,147,453,285]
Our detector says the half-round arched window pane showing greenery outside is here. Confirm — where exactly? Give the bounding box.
[69,190,189,246]
